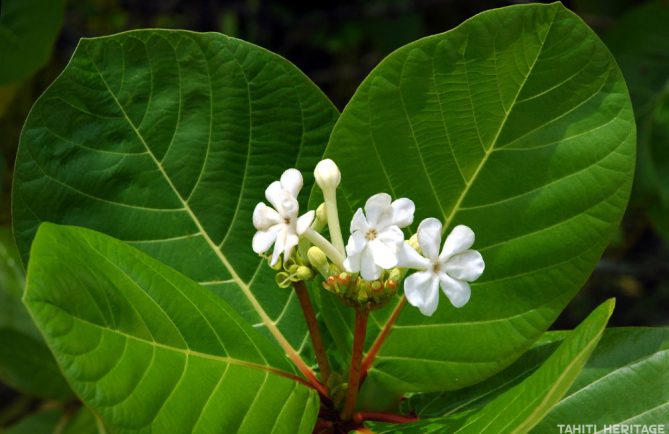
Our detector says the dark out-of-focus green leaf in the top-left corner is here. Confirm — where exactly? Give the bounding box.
[0,0,65,85]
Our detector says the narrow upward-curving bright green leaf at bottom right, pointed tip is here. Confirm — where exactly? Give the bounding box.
[368,299,615,434]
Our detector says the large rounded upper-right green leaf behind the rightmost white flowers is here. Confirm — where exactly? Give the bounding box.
[324,3,635,392]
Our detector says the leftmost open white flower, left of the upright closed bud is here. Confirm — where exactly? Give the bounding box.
[253,169,314,265]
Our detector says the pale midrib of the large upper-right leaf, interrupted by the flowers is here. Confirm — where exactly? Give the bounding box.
[370,10,558,362]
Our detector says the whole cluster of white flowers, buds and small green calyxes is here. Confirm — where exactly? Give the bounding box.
[252,159,485,316]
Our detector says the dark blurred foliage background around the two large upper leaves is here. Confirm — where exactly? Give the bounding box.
[0,0,669,427]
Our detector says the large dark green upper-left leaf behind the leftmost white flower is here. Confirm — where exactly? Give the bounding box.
[13,30,338,370]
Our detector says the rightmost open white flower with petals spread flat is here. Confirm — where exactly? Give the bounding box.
[399,218,485,316]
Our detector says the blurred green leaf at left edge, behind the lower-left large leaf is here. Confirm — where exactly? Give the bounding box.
[0,227,72,401]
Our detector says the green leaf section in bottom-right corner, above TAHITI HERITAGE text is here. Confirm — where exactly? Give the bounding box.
[533,327,669,428]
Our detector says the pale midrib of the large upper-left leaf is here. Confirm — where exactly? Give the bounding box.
[81,40,310,371]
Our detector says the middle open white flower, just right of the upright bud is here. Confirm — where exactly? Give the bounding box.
[344,193,416,280]
